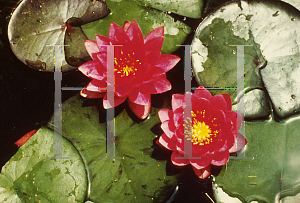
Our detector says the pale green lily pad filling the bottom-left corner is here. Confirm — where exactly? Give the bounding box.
[0,128,87,203]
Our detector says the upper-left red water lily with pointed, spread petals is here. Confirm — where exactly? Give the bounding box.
[78,20,180,119]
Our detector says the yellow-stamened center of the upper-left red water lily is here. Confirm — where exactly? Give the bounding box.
[114,51,141,77]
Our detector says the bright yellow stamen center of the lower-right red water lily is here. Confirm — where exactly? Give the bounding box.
[185,110,219,145]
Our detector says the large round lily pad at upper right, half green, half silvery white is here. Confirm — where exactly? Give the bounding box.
[192,1,300,118]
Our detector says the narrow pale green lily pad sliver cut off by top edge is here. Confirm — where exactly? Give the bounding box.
[137,0,204,18]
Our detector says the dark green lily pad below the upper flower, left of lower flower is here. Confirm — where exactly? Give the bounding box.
[50,95,177,203]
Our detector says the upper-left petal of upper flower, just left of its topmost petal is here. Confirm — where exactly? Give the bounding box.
[108,22,130,46]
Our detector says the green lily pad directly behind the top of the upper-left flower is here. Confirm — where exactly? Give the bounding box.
[82,0,191,54]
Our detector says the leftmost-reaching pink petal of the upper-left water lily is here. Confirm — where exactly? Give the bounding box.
[78,60,104,80]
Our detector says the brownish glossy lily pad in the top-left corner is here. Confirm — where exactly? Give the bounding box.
[8,0,109,72]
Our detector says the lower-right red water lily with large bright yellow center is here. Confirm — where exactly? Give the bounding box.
[158,87,246,179]
